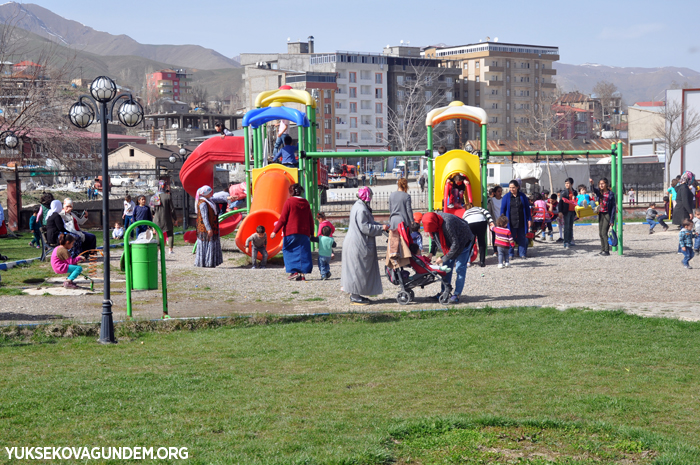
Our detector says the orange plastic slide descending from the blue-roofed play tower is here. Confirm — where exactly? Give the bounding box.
[236,164,296,259]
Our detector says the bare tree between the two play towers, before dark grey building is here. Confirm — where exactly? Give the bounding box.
[387,65,455,172]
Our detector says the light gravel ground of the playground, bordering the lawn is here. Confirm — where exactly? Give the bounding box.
[0,225,700,324]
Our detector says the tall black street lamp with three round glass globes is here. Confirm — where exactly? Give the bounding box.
[68,76,143,344]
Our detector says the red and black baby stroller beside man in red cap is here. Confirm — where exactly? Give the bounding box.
[386,223,452,305]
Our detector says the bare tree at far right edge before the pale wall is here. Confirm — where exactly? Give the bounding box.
[655,100,700,186]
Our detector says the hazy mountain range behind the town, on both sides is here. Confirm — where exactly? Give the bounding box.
[0,2,700,105]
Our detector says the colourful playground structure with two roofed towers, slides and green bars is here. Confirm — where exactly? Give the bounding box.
[181,86,623,256]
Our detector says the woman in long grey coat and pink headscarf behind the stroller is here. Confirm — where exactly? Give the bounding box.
[340,187,389,305]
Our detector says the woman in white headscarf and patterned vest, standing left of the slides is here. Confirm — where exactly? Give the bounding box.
[194,186,224,268]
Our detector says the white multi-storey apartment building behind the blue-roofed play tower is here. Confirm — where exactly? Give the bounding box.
[241,36,388,151]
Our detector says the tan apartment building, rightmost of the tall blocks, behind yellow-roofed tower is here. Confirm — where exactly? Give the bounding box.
[423,38,559,139]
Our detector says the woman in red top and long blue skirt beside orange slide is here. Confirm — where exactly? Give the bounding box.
[270,183,314,281]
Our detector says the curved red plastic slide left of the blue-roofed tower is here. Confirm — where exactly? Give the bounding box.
[180,136,245,236]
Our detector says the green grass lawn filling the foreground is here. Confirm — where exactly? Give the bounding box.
[0,309,700,464]
